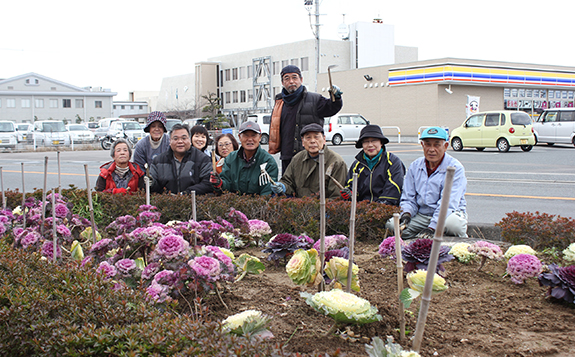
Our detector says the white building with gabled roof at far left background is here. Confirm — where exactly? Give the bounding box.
[0,73,117,122]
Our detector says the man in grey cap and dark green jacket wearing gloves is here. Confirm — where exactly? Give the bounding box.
[210,121,278,195]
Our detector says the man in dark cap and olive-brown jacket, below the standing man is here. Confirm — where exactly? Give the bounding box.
[272,123,347,198]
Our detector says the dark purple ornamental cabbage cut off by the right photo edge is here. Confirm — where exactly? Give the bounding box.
[539,264,575,304]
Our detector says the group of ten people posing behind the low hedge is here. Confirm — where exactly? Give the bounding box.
[96,65,467,239]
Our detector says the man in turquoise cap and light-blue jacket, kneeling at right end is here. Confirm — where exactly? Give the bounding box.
[399,126,467,239]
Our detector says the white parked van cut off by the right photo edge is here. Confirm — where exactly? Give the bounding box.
[533,108,575,145]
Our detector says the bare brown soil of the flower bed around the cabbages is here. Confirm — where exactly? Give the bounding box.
[208,243,575,357]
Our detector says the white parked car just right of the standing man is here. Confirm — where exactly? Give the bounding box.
[324,113,369,145]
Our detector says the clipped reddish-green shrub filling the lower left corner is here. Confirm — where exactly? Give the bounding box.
[0,242,290,356]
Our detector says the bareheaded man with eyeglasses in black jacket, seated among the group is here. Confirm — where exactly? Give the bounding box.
[150,124,212,195]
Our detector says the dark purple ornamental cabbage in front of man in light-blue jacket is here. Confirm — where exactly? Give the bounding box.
[401,239,455,274]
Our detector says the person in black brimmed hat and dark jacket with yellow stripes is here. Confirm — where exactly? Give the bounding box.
[341,125,405,206]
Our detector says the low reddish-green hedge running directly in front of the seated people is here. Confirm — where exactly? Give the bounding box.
[6,187,399,241]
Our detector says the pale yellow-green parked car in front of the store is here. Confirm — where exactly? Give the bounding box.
[451,110,535,152]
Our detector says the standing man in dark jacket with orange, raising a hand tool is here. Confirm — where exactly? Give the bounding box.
[269,65,343,174]
